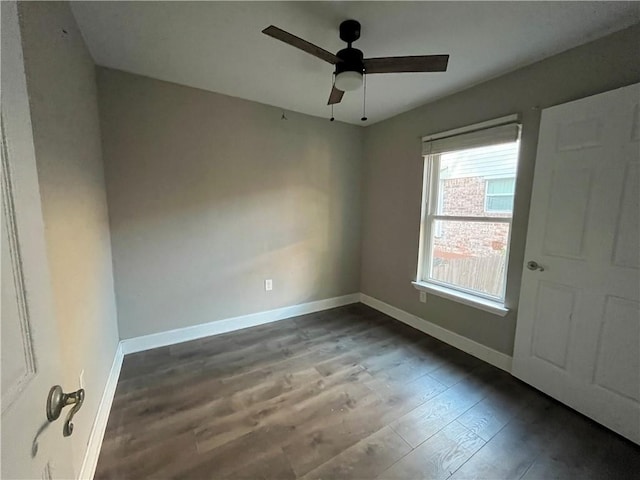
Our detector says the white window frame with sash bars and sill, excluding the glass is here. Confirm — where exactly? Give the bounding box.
[412,115,520,316]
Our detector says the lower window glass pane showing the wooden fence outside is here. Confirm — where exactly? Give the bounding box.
[430,220,509,297]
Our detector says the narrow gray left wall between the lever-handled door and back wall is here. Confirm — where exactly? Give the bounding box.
[19,2,118,473]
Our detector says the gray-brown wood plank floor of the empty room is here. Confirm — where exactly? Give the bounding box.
[95,304,640,480]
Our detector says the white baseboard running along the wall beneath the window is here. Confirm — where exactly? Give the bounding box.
[360,293,513,373]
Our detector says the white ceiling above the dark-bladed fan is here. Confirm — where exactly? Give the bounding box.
[72,1,640,124]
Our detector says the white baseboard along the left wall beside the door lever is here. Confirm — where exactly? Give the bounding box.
[78,342,124,480]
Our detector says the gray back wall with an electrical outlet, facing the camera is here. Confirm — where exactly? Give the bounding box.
[98,68,363,338]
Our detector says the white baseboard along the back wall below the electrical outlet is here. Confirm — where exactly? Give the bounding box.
[121,293,360,355]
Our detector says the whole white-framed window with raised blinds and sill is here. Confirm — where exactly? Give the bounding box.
[414,117,520,315]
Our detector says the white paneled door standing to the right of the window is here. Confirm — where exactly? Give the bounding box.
[513,84,640,443]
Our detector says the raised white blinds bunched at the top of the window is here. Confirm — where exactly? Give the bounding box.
[422,116,520,155]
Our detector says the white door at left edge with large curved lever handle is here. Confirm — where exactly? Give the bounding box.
[0,2,73,479]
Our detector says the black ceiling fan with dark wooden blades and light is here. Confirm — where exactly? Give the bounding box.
[262,20,449,105]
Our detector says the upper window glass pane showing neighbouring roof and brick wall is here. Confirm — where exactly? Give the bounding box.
[437,142,518,217]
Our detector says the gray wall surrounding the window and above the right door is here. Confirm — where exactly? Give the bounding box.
[361,26,640,354]
